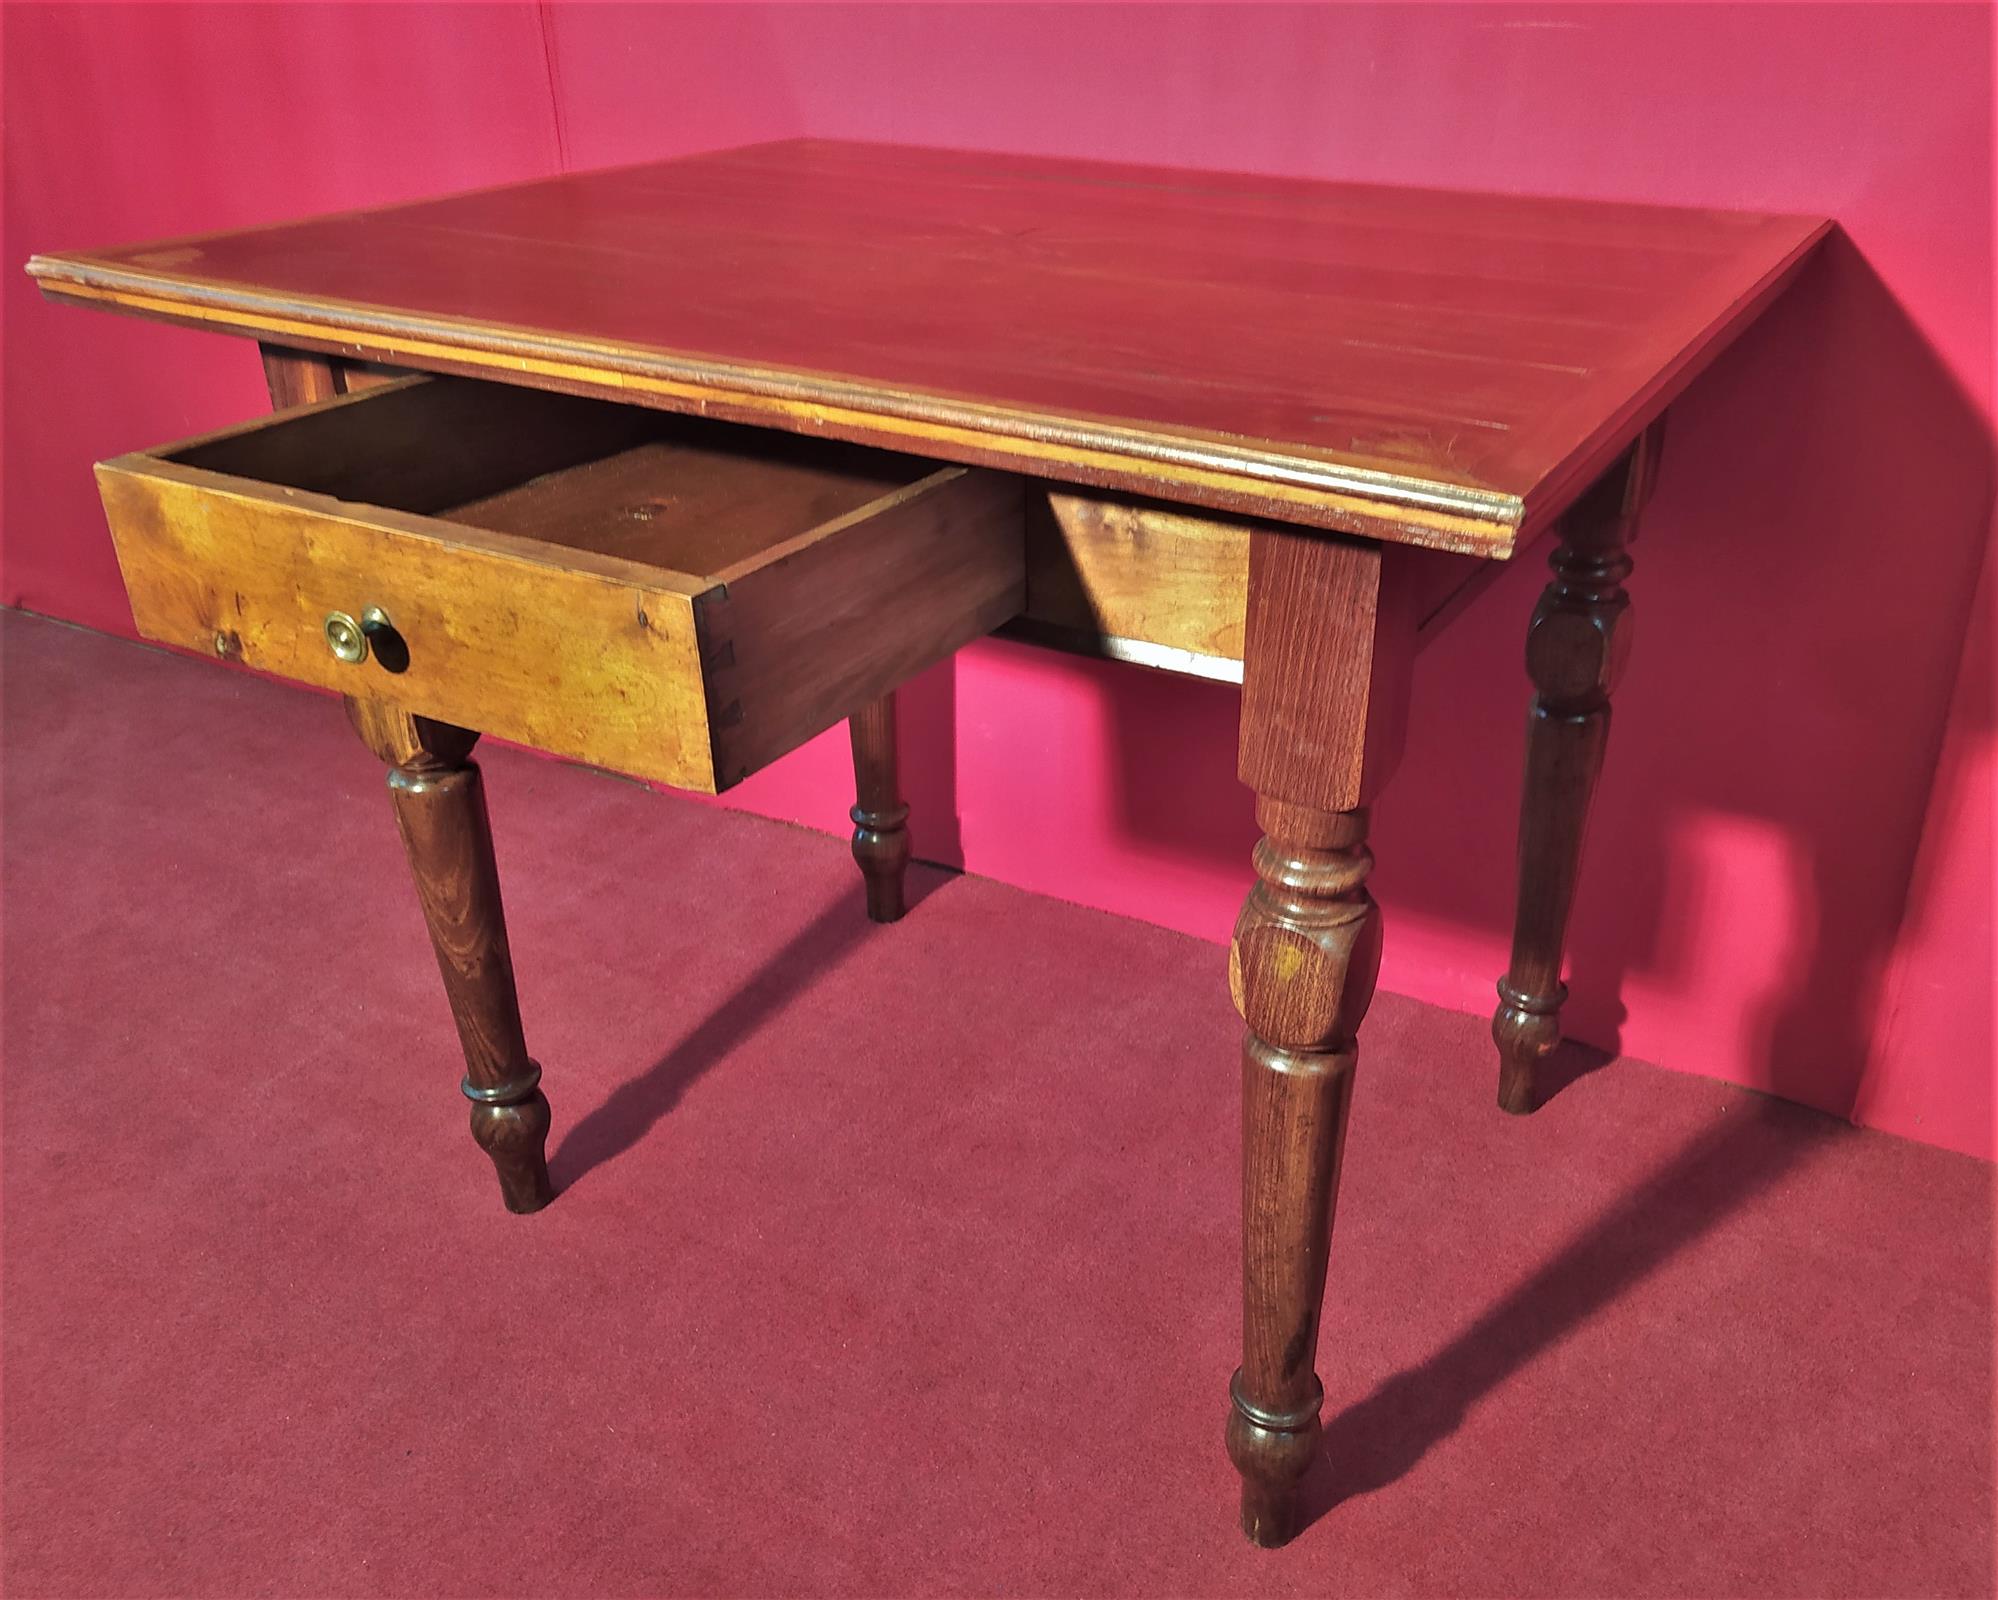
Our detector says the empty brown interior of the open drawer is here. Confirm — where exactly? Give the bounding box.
[162,378,937,581]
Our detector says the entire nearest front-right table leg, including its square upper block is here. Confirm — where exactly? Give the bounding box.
[1227,529,1415,1544]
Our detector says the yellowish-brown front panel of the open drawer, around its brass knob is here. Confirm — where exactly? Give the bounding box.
[98,465,727,789]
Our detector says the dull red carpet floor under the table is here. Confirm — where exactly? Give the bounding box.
[4,617,1992,1596]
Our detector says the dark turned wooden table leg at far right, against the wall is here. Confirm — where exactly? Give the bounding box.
[1493,427,1660,1113]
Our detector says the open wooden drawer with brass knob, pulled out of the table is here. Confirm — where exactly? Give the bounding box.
[98,378,1025,793]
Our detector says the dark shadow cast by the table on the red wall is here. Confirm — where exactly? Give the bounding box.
[1014,234,1994,1115]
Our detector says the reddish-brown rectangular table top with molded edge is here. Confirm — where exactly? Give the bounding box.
[28,140,1830,555]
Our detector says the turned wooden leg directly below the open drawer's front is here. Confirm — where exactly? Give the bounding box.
[348,699,553,1210]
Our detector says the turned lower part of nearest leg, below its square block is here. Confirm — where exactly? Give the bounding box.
[1227,797,1381,1546]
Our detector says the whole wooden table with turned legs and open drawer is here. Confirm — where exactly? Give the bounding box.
[28,142,1830,1544]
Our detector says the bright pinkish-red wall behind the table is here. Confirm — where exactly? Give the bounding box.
[4,4,1998,1155]
